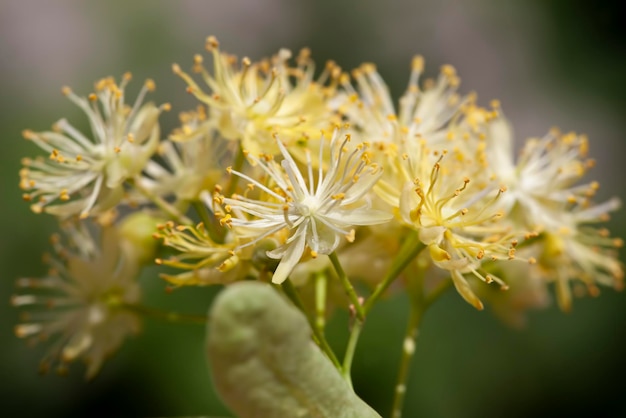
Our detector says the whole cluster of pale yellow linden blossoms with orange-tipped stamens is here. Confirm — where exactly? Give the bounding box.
[14,37,623,375]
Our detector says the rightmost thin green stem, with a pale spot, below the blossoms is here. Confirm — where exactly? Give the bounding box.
[391,302,424,418]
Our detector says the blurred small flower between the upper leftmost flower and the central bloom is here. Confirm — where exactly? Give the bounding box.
[139,106,234,201]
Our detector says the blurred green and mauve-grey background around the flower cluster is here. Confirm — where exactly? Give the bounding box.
[0,0,626,417]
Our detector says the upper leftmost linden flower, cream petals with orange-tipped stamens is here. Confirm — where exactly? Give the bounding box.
[20,73,169,218]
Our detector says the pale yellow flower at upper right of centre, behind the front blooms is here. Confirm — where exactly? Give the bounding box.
[340,56,497,206]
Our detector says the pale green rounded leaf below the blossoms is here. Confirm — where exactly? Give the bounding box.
[207,282,380,418]
